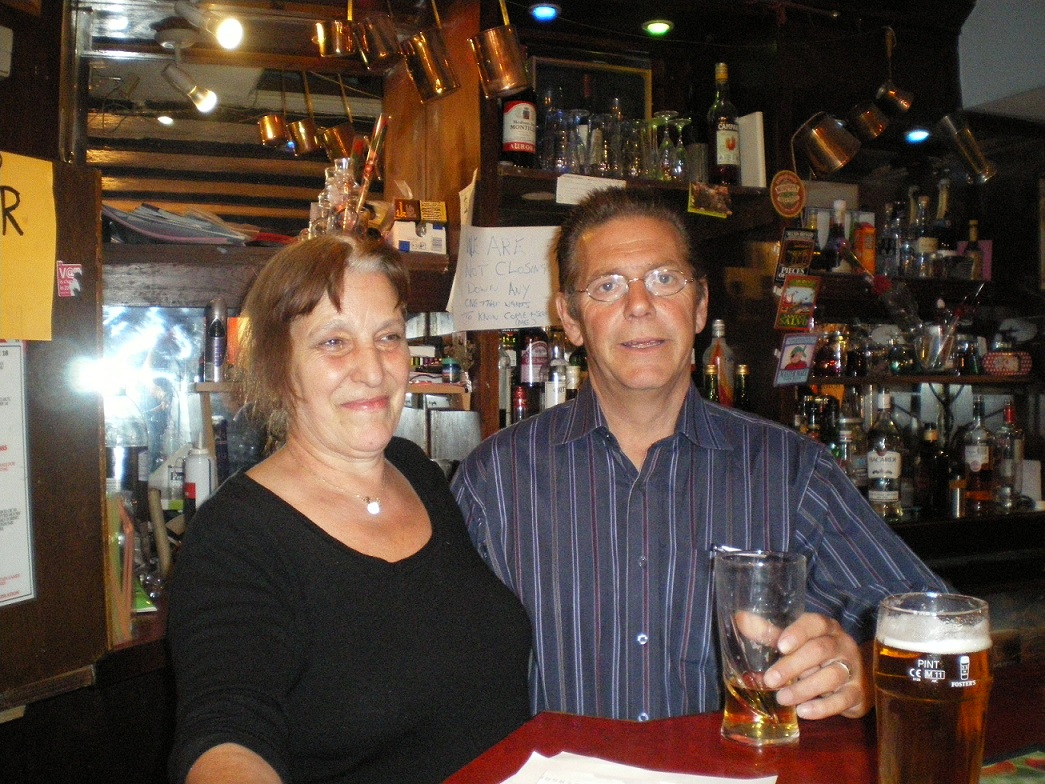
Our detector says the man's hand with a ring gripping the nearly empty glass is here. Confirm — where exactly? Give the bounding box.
[765,613,874,719]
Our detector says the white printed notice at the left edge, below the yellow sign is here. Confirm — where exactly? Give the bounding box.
[0,341,36,606]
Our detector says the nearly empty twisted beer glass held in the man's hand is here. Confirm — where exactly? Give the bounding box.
[715,551,806,746]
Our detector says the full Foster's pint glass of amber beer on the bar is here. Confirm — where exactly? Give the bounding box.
[875,593,992,784]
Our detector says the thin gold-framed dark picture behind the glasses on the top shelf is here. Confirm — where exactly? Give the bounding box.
[530,56,653,119]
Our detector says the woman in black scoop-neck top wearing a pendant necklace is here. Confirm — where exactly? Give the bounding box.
[168,236,530,784]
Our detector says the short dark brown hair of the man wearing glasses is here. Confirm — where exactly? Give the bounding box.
[555,188,705,297]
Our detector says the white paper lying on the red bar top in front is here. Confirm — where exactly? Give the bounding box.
[502,752,776,784]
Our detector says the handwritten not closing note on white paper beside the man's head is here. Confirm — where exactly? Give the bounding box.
[447,226,559,331]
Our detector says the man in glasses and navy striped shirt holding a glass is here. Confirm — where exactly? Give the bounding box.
[454,189,945,720]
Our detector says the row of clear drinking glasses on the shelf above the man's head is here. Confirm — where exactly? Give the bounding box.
[538,109,704,182]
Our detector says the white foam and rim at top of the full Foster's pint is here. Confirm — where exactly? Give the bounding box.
[876,595,991,655]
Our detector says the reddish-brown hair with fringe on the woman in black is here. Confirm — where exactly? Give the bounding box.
[239,235,410,437]
